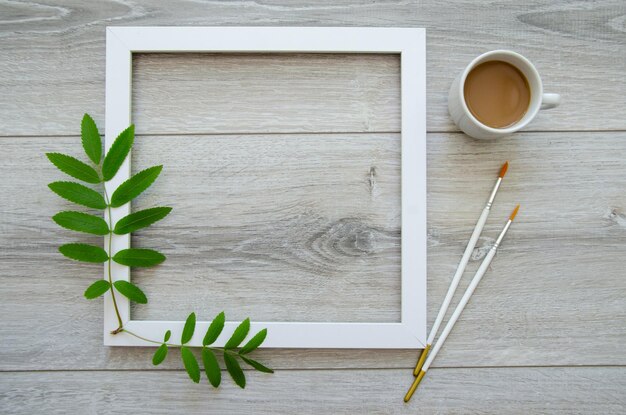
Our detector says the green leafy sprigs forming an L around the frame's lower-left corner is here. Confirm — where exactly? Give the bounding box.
[46,114,273,388]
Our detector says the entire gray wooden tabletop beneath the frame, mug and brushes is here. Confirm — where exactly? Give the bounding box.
[0,0,626,414]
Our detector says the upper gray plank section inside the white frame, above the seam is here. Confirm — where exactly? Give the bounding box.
[132,53,400,134]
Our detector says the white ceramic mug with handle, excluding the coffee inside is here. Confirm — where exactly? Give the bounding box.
[448,50,561,139]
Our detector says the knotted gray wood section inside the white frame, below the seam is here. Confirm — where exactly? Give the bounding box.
[133,134,401,322]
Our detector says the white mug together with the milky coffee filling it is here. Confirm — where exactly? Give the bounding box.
[448,50,561,139]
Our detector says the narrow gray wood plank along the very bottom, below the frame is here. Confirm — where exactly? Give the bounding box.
[0,367,626,415]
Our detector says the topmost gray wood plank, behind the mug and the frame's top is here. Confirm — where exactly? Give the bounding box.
[0,0,626,136]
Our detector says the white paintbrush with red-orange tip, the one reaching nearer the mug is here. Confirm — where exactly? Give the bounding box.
[413,161,509,376]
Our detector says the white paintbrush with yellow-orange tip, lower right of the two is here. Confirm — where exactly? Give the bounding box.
[404,205,519,402]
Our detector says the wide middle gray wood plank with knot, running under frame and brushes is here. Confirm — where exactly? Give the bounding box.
[0,133,626,370]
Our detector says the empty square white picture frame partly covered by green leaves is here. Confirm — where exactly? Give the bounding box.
[104,27,426,348]
